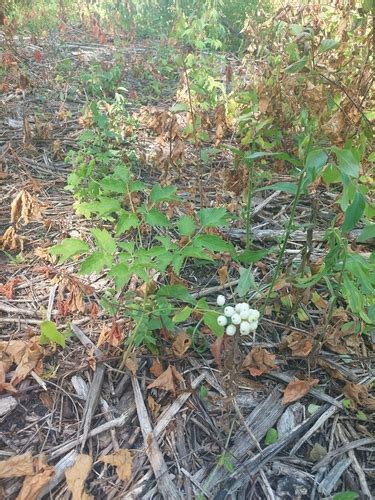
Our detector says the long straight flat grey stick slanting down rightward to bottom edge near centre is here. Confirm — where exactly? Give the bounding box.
[131,375,182,500]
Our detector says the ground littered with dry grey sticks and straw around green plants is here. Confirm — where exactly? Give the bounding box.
[0,26,375,499]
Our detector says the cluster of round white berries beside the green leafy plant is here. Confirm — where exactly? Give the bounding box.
[216,295,260,336]
